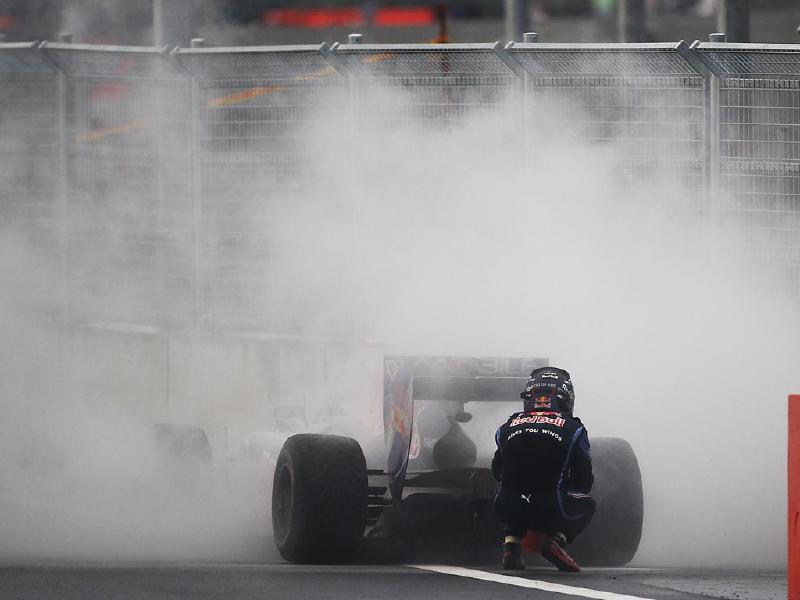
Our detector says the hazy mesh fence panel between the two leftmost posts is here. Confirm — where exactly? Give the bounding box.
[41,44,194,328]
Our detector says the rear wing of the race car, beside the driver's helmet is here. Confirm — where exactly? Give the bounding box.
[383,356,549,498]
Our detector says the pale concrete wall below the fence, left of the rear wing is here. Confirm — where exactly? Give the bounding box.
[50,327,382,459]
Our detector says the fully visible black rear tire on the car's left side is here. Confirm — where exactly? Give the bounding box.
[272,433,368,563]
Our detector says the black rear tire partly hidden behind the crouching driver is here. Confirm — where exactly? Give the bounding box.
[569,438,644,567]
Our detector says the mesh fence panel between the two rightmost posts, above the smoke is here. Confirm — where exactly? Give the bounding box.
[508,42,708,215]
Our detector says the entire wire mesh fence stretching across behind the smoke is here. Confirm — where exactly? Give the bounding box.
[0,42,800,335]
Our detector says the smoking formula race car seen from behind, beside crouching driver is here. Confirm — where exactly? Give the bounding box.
[272,356,643,566]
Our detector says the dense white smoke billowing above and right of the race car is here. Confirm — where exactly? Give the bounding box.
[266,84,798,566]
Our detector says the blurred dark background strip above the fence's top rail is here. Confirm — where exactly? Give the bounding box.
[0,0,800,46]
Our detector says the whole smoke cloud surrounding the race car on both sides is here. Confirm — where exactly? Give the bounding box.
[0,57,800,566]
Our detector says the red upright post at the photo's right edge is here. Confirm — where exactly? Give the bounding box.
[786,396,800,600]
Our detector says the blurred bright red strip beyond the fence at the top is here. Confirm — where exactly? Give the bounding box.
[261,6,436,29]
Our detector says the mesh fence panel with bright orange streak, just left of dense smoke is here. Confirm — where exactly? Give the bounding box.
[173,46,346,334]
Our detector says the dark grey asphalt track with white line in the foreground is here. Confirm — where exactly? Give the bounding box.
[0,563,786,600]
